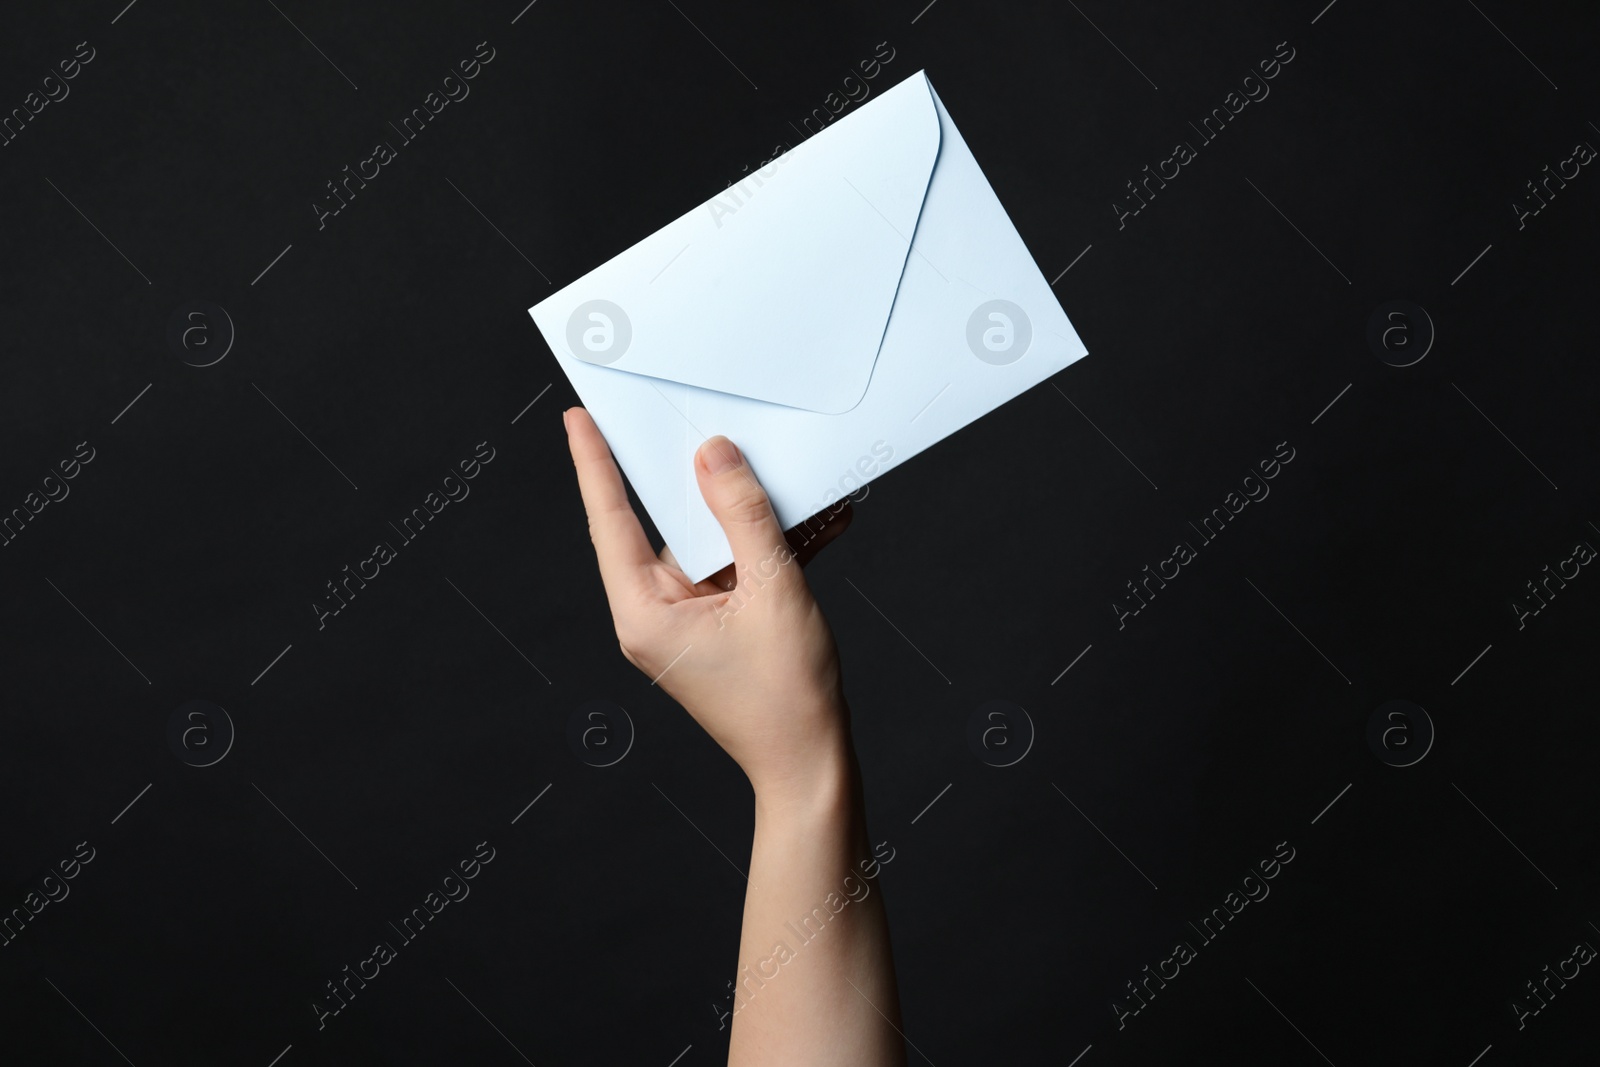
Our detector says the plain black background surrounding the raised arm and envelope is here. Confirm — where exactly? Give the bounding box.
[0,0,1600,1067]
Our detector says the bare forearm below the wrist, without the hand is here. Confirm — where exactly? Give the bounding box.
[728,739,906,1067]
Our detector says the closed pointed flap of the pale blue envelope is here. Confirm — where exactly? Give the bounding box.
[534,72,939,414]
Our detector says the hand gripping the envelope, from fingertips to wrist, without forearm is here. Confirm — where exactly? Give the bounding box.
[562,408,851,805]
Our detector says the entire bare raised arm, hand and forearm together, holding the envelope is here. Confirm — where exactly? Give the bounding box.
[562,408,906,1067]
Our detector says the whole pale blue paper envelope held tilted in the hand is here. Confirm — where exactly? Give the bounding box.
[528,72,1086,581]
